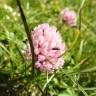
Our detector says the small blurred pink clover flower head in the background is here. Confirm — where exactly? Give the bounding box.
[60,8,77,27]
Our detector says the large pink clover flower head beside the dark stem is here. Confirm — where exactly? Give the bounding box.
[25,23,65,73]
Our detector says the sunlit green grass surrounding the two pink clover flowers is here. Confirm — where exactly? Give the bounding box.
[0,0,96,96]
